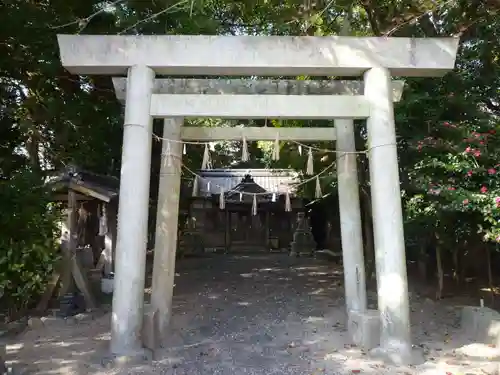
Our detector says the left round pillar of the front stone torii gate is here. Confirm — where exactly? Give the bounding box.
[111,65,155,357]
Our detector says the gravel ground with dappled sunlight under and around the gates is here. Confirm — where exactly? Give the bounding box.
[3,255,499,375]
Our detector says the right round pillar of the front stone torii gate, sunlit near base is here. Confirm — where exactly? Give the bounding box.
[364,68,415,364]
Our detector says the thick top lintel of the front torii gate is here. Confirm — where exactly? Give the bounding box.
[57,35,459,77]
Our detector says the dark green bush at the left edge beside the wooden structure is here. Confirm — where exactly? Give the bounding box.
[0,171,59,318]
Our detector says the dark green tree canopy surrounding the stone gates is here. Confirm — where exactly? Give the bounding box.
[0,0,500,312]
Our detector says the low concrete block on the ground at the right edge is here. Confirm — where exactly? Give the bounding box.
[461,306,500,347]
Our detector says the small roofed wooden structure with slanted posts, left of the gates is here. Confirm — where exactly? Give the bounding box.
[37,166,119,312]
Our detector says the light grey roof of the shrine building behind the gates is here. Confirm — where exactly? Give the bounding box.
[199,169,298,196]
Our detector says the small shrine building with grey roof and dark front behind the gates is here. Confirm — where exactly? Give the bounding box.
[181,169,304,253]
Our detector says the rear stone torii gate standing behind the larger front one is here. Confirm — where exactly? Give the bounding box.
[113,77,404,344]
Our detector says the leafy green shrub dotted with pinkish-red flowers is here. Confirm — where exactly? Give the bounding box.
[407,117,500,242]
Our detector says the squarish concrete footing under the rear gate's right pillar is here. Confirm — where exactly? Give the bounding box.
[348,310,380,350]
